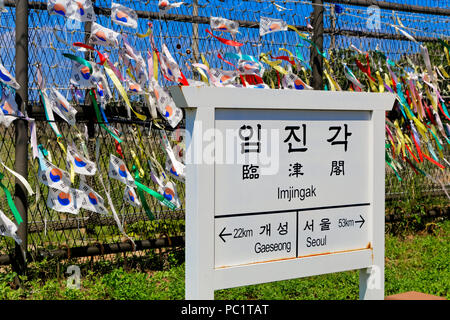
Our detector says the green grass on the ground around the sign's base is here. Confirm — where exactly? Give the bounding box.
[0,221,450,300]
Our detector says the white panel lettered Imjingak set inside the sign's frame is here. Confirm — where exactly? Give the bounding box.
[214,109,370,268]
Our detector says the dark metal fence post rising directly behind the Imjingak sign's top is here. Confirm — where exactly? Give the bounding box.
[311,0,323,90]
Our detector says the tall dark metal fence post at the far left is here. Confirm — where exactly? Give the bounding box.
[13,0,28,274]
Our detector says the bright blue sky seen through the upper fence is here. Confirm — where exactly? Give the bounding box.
[0,0,450,100]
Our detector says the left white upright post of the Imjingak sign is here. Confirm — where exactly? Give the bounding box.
[185,108,214,300]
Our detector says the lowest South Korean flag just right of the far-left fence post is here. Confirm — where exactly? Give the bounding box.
[47,188,83,214]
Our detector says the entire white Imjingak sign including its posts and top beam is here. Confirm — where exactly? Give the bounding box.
[171,87,395,300]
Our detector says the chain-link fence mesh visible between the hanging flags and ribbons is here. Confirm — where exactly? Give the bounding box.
[0,0,450,270]
